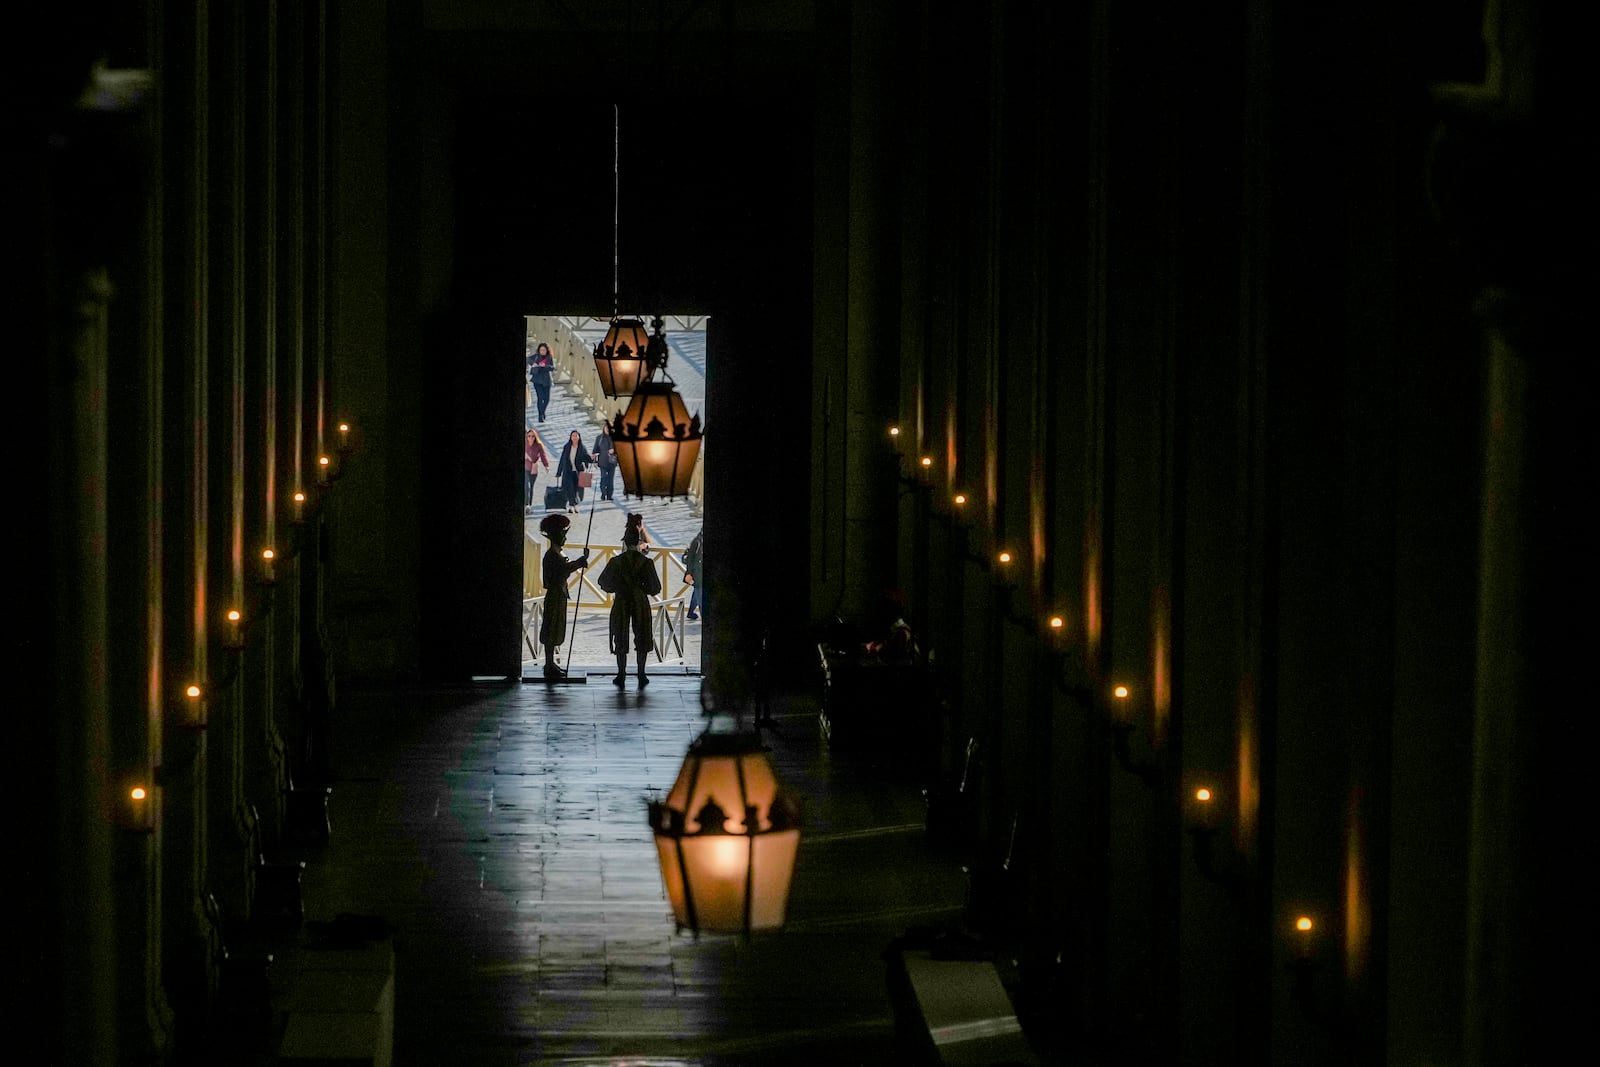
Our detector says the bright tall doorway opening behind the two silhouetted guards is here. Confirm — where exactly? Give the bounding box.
[522,314,709,680]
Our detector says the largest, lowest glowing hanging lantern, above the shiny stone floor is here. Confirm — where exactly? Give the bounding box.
[650,733,800,934]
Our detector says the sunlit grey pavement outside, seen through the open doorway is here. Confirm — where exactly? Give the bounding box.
[522,321,706,685]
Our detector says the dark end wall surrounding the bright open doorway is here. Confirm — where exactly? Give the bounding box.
[419,85,811,686]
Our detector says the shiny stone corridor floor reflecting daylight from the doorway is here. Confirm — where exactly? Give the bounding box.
[285,675,965,1065]
